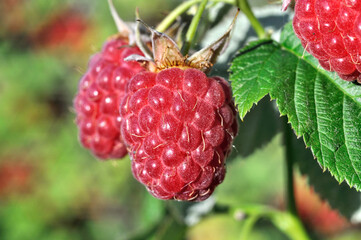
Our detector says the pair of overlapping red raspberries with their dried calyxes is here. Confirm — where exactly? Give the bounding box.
[74,1,238,201]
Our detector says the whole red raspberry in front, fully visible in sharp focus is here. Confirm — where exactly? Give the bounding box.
[121,67,237,201]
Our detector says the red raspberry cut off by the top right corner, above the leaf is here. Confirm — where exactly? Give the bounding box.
[293,0,361,82]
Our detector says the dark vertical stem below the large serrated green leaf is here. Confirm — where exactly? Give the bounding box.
[282,117,298,217]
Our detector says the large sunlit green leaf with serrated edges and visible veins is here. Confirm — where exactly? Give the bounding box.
[231,24,361,190]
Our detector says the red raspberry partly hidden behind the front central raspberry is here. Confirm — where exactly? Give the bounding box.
[74,36,143,159]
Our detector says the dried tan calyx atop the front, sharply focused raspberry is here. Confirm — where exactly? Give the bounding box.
[125,11,239,73]
